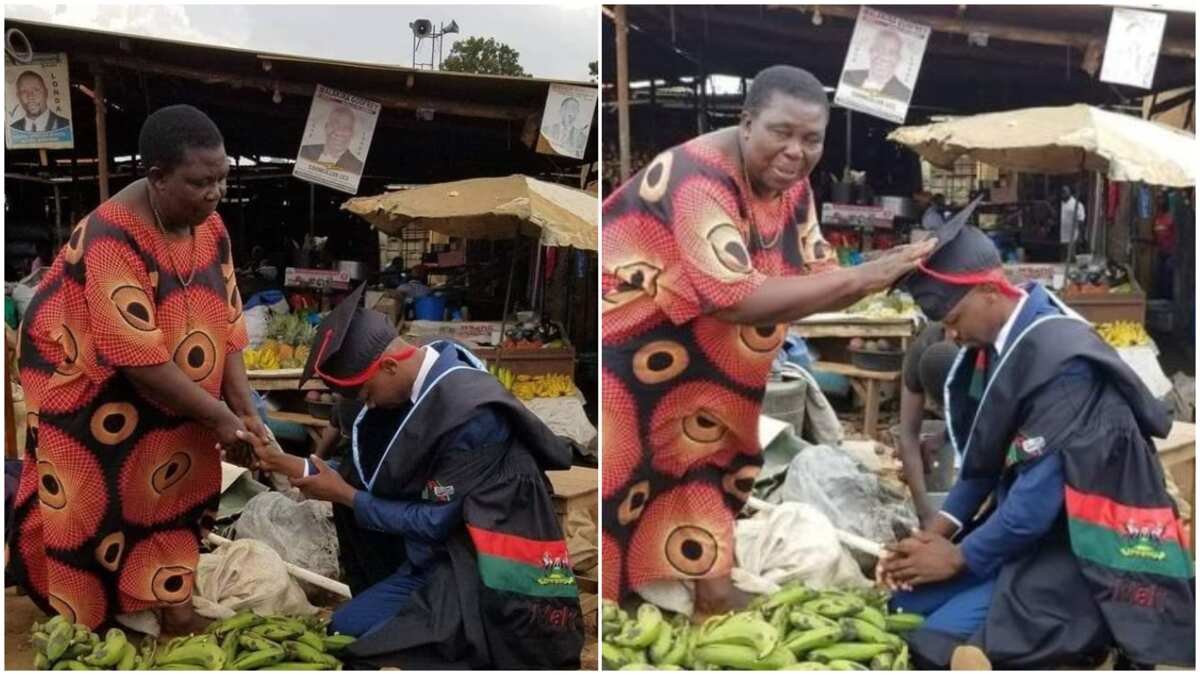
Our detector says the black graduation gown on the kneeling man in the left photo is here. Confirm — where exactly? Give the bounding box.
[340,342,583,670]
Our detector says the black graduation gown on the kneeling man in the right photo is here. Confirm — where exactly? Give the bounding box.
[931,287,1195,668]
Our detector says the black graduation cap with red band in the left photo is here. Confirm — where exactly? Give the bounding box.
[300,283,397,399]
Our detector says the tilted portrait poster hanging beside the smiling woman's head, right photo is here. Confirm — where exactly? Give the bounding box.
[833,7,930,124]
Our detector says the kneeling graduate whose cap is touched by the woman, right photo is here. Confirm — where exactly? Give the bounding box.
[880,200,1195,669]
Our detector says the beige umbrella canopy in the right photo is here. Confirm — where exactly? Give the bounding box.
[888,103,1196,187]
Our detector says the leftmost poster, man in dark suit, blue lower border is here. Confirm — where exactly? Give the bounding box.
[4,54,74,150]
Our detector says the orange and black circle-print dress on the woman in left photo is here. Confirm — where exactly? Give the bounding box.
[8,203,246,628]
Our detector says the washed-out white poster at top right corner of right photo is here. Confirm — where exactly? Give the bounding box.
[1100,7,1166,89]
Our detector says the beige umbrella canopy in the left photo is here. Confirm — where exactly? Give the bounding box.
[342,175,598,251]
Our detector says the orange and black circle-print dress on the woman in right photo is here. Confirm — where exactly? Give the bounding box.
[601,133,836,599]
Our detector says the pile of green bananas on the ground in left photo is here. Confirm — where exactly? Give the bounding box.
[31,611,354,670]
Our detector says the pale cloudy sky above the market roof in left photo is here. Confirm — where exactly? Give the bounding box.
[5,4,599,80]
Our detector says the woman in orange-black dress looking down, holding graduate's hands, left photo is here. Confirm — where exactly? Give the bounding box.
[8,106,262,631]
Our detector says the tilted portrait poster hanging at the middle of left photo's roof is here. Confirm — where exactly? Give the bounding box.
[292,84,380,195]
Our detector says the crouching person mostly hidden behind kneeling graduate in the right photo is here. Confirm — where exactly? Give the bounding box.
[896,321,959,527]
